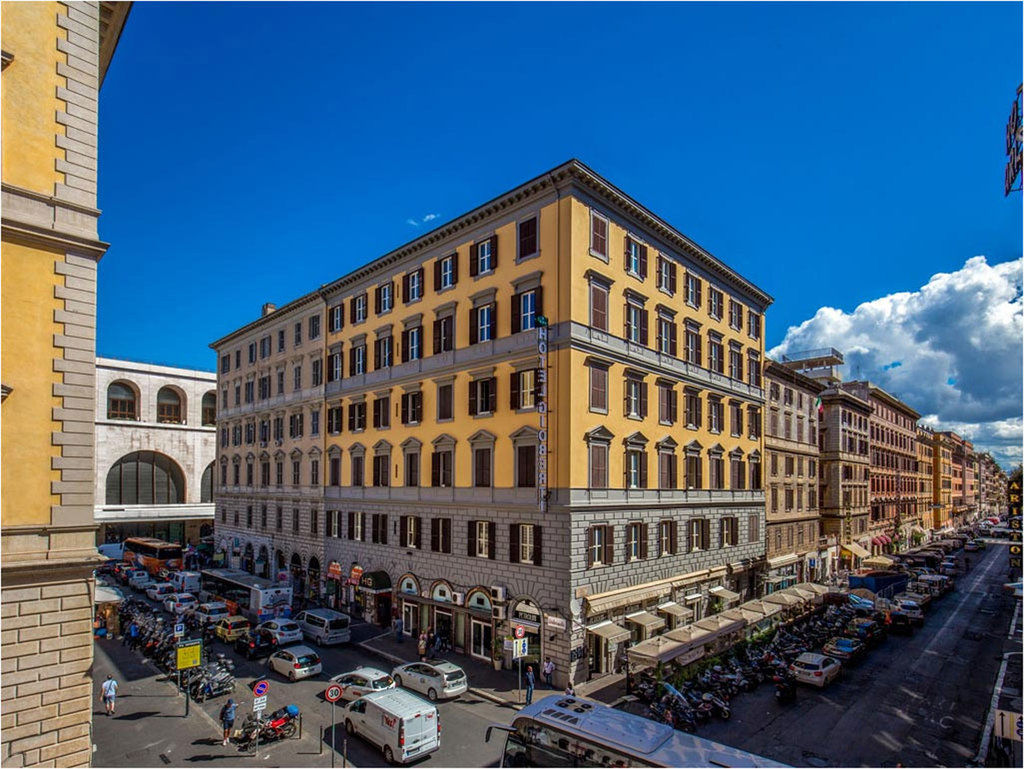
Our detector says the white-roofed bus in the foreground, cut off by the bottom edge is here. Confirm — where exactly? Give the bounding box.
[484,694,786,767]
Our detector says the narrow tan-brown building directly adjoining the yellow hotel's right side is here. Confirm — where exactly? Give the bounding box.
[764,359,828,592]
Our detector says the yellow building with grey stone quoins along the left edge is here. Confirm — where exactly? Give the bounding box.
[0,2,130,766]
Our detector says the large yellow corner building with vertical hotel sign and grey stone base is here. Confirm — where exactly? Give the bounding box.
[212,161,771,681]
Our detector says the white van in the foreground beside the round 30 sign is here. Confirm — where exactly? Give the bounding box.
[345,689,441,764]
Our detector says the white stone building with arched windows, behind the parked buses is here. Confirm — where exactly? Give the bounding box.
[95,357,217,545]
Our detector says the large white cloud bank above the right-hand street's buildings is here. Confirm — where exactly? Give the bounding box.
[769,256,1024,465]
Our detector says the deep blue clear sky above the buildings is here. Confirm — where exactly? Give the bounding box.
[98,3,1022,460]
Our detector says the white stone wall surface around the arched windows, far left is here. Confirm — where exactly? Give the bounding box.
[95,357,217,511]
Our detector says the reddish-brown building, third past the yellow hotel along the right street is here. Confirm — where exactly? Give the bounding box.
[842,381,921,553]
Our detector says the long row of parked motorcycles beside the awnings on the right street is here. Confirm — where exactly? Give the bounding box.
[633,605,856,732]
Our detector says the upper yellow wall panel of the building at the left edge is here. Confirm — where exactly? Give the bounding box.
[0,2,66,195]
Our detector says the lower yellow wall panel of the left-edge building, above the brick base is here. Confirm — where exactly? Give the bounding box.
[0,243,63,526]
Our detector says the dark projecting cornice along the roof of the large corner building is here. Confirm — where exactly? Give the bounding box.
[210,158,774,349]
